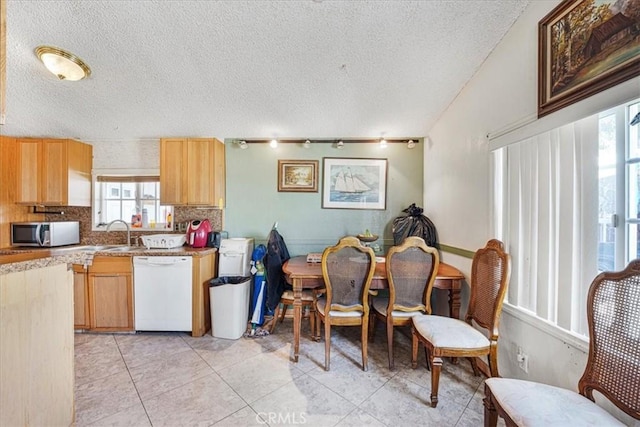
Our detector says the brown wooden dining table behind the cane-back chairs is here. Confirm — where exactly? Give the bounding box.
[282,256,464,362]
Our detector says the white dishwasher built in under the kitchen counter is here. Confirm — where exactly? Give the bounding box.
[133,256,193,331]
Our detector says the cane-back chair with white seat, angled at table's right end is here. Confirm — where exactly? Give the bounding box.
[411,239,511,408]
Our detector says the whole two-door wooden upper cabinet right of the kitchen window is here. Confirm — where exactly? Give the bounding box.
[160,138,225,208]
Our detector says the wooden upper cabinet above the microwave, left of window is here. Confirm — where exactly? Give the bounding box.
[16,138,93,206]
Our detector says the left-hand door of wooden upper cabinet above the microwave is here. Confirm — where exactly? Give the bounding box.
[16,139,42,204]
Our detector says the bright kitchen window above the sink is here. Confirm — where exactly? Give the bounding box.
[94,175,173,229]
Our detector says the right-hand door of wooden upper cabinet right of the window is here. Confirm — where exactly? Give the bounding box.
[186,138,215,206]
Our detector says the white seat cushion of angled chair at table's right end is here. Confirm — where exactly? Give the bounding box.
[413,314,490,350]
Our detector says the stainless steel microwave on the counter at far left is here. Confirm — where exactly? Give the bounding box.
[11,221,80,248]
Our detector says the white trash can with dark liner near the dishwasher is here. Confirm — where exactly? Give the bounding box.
[209,276,251,340]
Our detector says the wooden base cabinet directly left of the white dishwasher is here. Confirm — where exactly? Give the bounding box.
[88,256,133,332]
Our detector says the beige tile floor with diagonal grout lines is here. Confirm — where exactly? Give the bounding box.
[75,319,496,427]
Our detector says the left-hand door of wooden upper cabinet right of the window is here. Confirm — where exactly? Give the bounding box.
[160,139,188,205]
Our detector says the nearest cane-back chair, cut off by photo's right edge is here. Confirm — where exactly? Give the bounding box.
[484,259,640,426]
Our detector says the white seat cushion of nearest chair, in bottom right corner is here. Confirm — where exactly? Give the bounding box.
[485,378,624,427]
